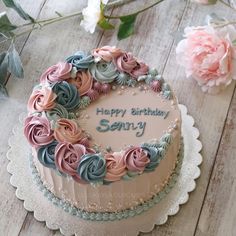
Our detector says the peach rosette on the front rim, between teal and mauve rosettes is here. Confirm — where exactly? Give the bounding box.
[105,152,127,182]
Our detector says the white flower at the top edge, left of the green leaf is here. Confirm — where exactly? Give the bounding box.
[80,0,109,34]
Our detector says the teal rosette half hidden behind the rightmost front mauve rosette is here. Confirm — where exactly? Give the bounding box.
[141,144,160,172]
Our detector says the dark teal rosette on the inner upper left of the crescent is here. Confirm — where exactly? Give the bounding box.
[52,81,80,111]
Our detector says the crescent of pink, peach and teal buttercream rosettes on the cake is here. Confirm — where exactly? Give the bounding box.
[24,46,173,184]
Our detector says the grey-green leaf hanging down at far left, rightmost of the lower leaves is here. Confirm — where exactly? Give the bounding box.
[8,45,24,78]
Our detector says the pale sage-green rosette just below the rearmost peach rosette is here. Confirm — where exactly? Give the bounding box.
[89,61,119,83]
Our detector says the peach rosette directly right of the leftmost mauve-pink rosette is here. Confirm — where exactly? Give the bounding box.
[54,119,84,144]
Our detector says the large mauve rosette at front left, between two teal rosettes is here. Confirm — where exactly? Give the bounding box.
[55,143,86,183]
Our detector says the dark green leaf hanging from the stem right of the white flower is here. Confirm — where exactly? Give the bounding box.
[117,14,137,40]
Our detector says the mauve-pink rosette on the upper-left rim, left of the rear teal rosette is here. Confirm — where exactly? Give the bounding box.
[40,62,72,83]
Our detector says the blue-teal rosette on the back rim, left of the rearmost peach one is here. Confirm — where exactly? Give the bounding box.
[66,51,94,69]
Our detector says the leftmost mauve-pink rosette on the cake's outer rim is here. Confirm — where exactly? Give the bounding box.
[24,116,54,148]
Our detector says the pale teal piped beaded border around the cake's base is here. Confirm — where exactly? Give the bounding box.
[29,138,184,221]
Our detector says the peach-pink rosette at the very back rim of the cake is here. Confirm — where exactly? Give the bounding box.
[92,46,122,62]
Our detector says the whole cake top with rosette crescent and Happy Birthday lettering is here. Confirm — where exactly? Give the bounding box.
[24,46,180,184]
